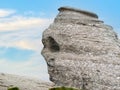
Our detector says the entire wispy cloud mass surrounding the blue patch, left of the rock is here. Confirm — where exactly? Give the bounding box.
[0,9,52,80]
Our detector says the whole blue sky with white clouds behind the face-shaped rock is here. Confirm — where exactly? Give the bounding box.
[0,0,120,81]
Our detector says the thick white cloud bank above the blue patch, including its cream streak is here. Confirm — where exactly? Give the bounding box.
[0,10,52,52]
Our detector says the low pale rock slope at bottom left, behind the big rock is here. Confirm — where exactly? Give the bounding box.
[0,73,54,90]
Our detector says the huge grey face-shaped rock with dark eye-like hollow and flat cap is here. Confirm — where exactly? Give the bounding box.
[42,7,120,90]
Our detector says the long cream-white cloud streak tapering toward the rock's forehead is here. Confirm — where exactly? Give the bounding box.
[0,16,51,31]
